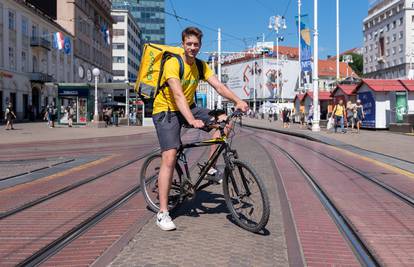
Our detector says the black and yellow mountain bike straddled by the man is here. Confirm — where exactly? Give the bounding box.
[140,110,270,233]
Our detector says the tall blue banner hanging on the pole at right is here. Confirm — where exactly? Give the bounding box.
[295,14,312,88]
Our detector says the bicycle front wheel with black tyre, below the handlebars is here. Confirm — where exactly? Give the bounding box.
[223,160,270,233]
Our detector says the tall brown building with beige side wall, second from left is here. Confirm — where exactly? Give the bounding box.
[55,0,113,83]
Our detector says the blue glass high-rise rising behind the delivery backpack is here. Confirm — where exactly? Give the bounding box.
[112,0,165,44]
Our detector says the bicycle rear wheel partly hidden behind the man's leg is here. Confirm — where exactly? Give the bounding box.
[140,154,181,212]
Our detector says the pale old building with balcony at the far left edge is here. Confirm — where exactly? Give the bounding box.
[0,0,74,120]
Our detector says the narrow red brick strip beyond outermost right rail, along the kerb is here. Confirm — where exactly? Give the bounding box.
[269,134,414,196]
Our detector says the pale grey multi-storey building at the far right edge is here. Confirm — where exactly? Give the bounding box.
[363,0,414,79]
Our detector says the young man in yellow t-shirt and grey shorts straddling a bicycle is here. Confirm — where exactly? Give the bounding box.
[153,27,248,231]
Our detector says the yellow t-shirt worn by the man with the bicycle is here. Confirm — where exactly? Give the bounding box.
[152,55,214,114]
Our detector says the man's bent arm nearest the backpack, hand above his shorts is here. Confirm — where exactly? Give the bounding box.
[167,78,204,128]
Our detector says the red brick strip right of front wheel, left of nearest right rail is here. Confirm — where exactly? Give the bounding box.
[261,140,359,266]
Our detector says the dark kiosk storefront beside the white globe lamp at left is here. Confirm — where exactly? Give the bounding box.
[57,84,93,124]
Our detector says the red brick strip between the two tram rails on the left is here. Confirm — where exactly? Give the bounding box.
[0,161,146,264]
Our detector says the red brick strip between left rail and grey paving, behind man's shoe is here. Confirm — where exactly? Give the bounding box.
[42,135,206,266]
